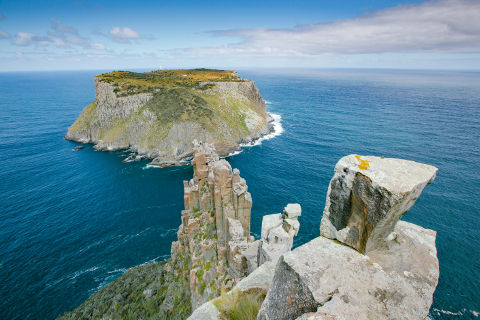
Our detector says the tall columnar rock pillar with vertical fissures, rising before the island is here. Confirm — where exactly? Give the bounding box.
[172,143,258,308]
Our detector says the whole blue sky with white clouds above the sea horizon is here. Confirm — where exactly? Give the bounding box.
[0,0,480,71]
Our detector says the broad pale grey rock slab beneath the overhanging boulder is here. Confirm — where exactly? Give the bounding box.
[257,222,439,320]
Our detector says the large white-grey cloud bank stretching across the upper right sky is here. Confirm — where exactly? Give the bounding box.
[202,0,480,56]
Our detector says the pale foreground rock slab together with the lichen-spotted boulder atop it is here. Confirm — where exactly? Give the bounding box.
[257,155,439,320]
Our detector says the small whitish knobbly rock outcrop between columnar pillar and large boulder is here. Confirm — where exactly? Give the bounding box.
[258,203,302,265]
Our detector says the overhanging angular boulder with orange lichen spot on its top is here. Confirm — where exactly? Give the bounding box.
[320,155,437,253]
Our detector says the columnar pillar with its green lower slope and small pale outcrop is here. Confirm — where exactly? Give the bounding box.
[62,140,301,319]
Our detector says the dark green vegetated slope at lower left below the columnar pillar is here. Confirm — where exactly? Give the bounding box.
[60,262,191,320]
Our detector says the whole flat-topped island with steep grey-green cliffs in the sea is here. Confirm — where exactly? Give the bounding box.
[65,69,273,166]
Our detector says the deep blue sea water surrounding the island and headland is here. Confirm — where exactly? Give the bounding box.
[0,70,480,319]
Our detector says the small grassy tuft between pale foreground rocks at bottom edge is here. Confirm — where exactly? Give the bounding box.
[212,290,265,320]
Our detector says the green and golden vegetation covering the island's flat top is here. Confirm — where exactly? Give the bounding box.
[98,69,245,96]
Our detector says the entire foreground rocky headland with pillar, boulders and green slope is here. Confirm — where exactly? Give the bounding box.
[63,143,439,320]
